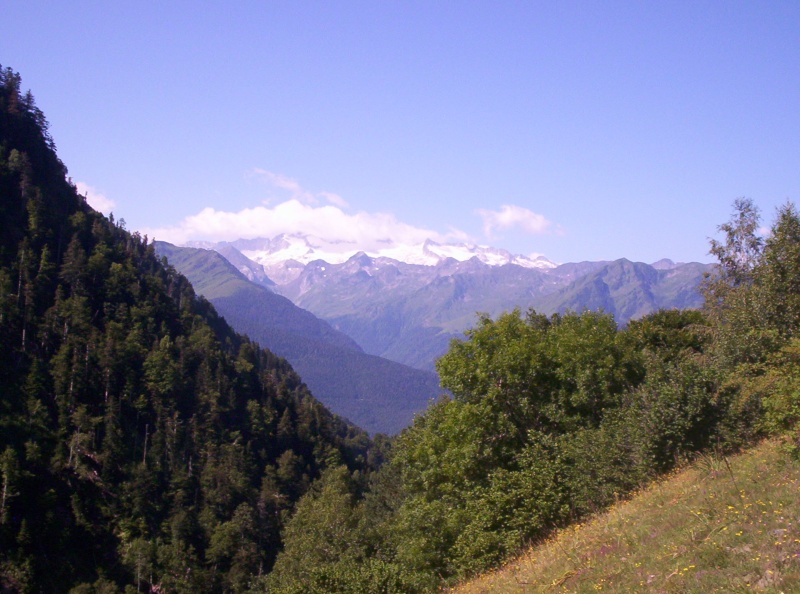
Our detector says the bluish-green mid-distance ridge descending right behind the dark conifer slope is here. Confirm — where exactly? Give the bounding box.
[156,242,441,434]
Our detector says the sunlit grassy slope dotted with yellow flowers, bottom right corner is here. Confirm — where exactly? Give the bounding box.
[451,441,800,594]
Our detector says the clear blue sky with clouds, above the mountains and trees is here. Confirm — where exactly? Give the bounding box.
[0,0,800,262]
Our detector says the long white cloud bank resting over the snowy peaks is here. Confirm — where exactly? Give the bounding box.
[142,198,456,246]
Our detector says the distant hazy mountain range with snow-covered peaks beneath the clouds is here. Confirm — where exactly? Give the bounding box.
[192,235,711,370]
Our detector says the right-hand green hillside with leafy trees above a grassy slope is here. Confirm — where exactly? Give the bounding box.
[253,199,800,594]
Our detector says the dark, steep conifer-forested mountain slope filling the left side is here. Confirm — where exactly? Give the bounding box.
[0,69,380,592]
